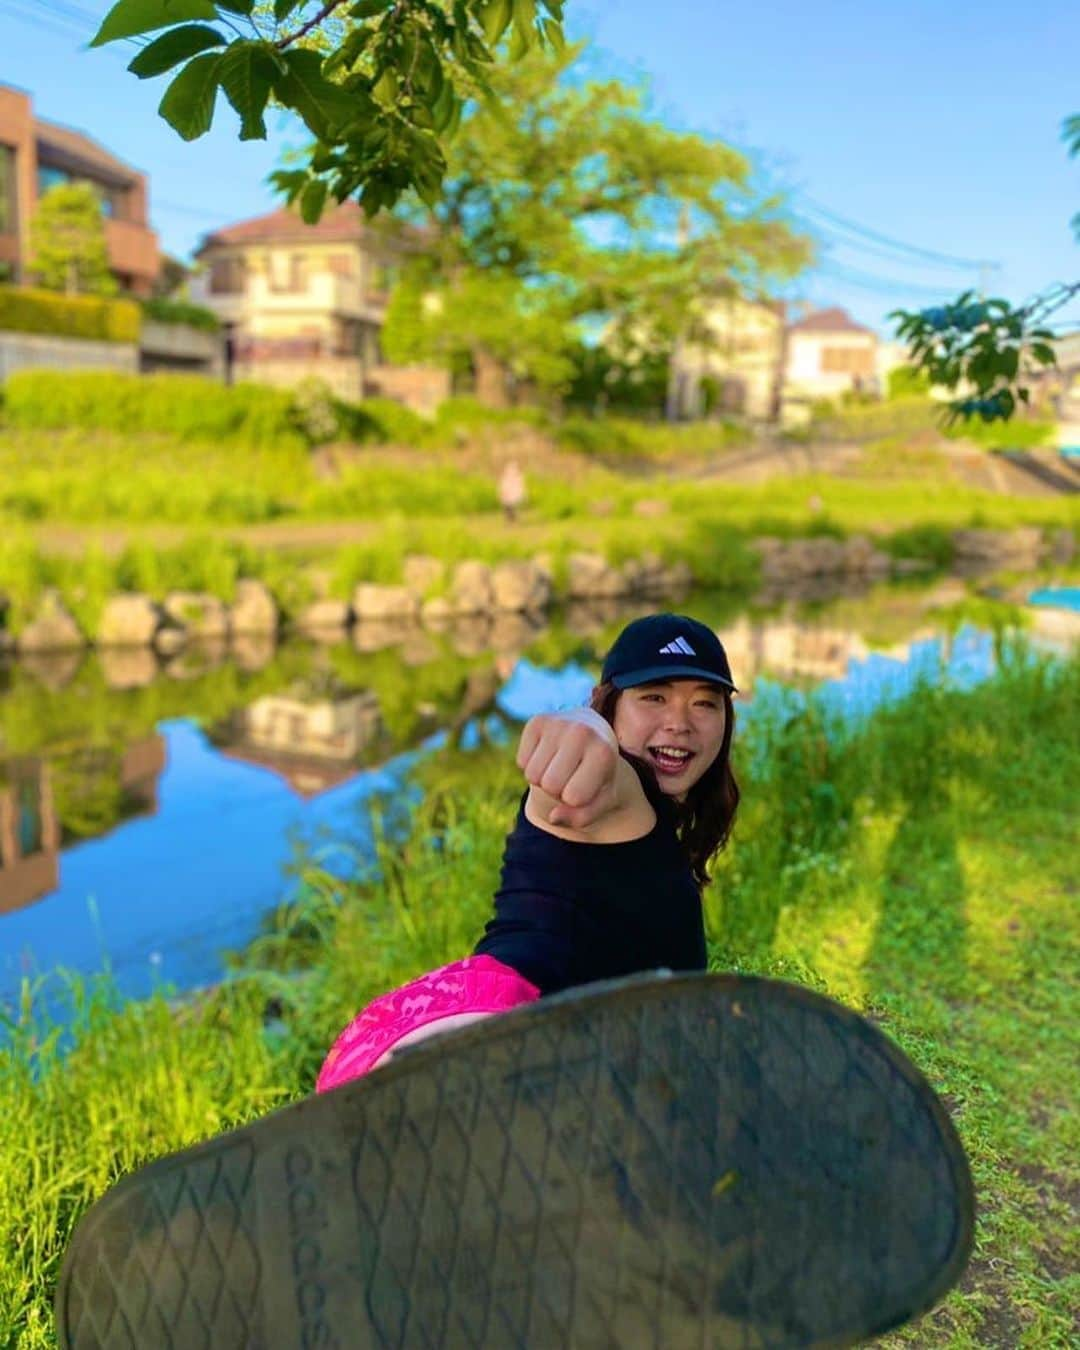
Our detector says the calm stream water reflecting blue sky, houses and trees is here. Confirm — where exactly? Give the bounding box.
[0,583,1063,1003]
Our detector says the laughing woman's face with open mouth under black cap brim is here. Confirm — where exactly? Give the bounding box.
[614,679,728,802]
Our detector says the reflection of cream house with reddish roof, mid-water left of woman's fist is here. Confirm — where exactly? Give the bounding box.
[213,691,382,797]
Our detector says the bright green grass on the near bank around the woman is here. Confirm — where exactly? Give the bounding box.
[0,648,1080,1350]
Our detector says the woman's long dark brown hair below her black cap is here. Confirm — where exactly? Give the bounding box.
[590,683,738,887]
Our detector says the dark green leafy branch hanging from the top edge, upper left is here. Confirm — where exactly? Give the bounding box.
[90,0,563,220]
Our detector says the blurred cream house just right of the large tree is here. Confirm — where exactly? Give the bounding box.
[668,294,784,421]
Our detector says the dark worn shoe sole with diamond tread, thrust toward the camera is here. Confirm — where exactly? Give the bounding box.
[57,975,973,1350]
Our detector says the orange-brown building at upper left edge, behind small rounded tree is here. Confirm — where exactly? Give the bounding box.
[0,85,159,296]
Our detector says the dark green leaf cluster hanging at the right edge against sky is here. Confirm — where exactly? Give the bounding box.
[890,113,1080,423]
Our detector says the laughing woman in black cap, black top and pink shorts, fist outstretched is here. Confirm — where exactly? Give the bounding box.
[316,614,738,1092]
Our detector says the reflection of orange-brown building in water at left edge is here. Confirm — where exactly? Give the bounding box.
[0,734,165,914]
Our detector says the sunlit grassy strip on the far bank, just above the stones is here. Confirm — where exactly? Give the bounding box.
[0,468,1080,633]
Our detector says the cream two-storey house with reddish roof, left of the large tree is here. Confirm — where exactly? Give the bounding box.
[189,200,450,410]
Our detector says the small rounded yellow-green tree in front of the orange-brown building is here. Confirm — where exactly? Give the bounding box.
[30,182,116,296]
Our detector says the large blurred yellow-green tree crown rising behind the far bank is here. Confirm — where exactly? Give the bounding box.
[375,47,810,401]
